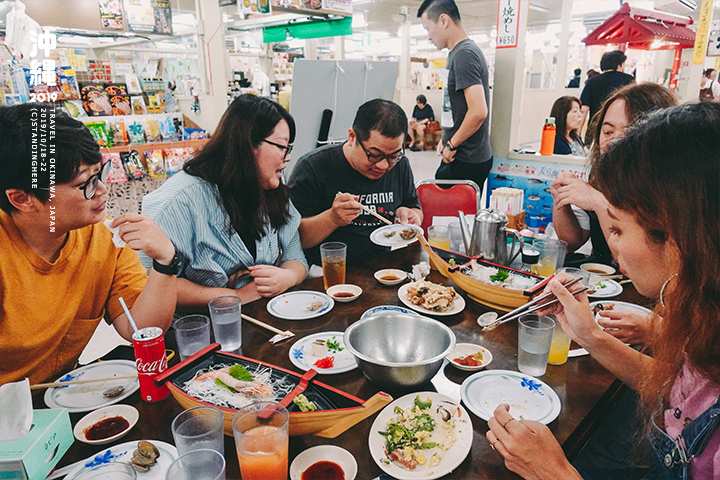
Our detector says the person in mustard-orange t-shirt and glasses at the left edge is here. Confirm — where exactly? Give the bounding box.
[0,103,177,384]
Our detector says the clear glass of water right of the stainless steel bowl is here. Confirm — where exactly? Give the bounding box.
[518,313,555,377]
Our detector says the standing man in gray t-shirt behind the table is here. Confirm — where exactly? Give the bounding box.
[418,0,492,188]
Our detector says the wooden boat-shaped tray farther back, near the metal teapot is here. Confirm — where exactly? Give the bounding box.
[418,235,552,312]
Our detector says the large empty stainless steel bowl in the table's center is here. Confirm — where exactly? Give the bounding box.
[344,311,455,389]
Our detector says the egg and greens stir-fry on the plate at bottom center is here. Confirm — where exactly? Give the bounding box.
[379,395,461,470]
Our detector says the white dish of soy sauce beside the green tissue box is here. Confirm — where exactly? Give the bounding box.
[73,405,140,445]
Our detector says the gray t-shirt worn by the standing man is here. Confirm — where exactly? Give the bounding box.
[442,38,492,163]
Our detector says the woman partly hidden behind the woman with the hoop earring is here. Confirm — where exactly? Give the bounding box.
[550,83,677,343]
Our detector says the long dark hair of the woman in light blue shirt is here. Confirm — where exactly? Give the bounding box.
[183,94,295,240]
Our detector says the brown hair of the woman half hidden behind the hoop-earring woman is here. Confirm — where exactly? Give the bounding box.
[588,82,677,158]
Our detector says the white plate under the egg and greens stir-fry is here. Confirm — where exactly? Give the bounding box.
[368,392,473,480]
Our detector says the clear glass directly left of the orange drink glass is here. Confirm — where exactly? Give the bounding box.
[171,406,225,455]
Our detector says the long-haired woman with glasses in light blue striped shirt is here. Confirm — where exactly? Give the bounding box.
[142,94,307,309]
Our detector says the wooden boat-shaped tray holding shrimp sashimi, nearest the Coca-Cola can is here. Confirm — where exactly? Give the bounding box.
[155,343,393,438]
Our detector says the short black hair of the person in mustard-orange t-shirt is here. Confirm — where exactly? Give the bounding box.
[0,103,102,213]
